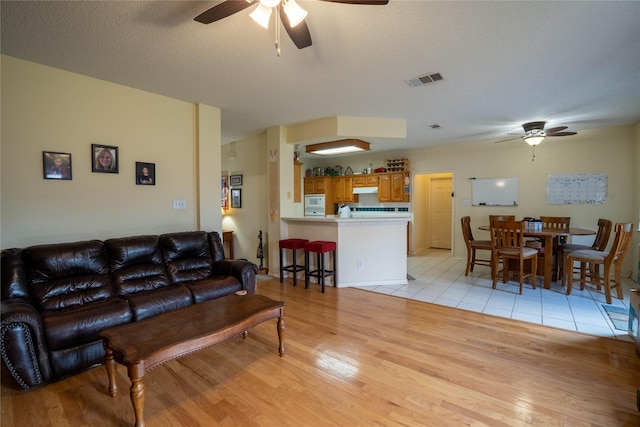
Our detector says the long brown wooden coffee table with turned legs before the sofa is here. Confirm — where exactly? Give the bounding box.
[100,294,285,427]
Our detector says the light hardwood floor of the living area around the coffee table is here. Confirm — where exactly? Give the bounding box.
[1,279,640,427]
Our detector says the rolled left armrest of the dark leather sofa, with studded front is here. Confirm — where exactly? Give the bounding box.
[0,299,51,389]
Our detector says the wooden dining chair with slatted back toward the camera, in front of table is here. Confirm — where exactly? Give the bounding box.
[490,221,538,294]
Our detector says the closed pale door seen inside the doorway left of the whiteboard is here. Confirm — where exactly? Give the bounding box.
[429,178,453,249]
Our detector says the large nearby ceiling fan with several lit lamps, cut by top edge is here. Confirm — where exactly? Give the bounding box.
[194,0,389,56]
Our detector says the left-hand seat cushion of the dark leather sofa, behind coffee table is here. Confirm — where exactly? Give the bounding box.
[42,297,133,350]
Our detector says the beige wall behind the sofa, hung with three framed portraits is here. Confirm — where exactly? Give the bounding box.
[0,55,220,248]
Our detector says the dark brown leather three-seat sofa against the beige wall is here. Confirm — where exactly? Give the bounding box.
[0,231,257,388]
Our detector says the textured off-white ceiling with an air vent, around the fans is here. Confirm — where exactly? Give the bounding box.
[1,0,640,155]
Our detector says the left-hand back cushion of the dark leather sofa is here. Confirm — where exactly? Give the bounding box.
[23,240,115,310]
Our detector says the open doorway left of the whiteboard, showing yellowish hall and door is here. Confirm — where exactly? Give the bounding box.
[410,172,453,254]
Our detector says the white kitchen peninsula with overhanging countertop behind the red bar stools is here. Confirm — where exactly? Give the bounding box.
[282,215,410,287]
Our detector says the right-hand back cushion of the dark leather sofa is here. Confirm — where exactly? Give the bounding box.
[160,231,213,283]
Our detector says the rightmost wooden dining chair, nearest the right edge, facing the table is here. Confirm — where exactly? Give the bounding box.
[562,222,633,304]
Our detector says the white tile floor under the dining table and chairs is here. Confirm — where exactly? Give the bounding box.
[362,249,636,341]
